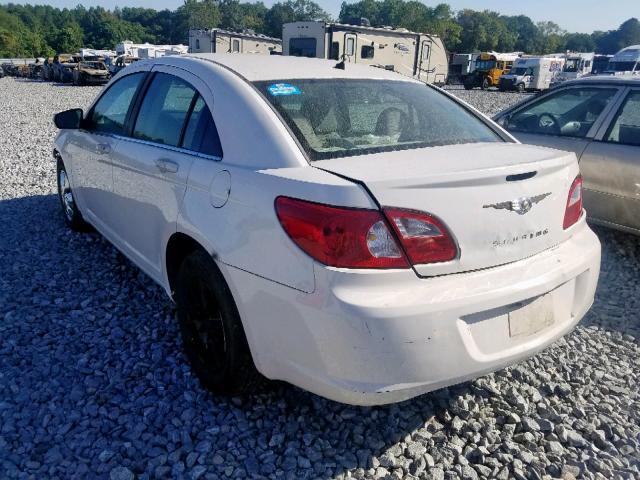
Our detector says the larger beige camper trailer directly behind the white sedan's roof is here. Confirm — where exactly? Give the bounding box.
[282,22,449,85]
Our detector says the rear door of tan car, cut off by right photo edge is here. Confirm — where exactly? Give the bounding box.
[580,88,640,230]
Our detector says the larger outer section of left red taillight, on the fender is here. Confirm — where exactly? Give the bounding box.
[275,197,409,268]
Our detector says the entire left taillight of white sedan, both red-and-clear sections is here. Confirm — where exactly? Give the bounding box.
[275,197,457,268]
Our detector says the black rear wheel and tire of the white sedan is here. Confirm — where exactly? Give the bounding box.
[175,250,264,396]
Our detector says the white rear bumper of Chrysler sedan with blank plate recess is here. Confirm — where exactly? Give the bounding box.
[223,223,600,405]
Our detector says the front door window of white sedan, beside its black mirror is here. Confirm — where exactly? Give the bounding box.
[87,72,145,135]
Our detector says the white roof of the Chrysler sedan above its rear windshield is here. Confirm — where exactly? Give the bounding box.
[165,53,417,82]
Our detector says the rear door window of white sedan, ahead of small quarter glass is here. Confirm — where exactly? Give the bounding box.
[133,73,196,147]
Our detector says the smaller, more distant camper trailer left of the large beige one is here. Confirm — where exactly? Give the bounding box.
[189,28,282,55]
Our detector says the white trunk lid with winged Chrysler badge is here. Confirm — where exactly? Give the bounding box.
[313,143,578,276]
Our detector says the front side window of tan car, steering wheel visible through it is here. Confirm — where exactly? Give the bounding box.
[505,87,618,138]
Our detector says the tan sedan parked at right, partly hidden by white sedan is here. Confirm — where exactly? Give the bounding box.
[495,75,640,234]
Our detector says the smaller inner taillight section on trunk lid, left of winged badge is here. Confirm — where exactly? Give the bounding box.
[384,208,458,265]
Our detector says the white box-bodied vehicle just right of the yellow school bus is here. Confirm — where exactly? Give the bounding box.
[500,56,565,92]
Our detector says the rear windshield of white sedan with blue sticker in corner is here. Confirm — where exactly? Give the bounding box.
[255,79,503,160]
